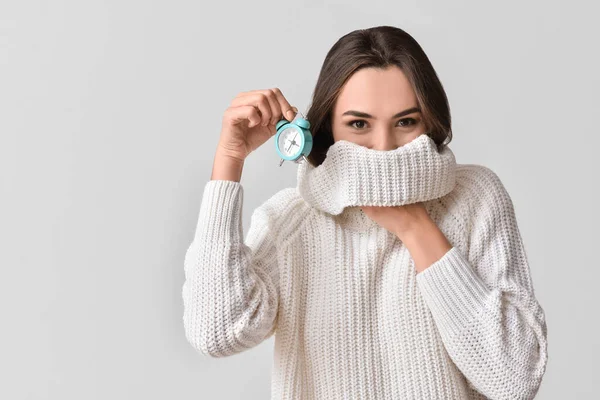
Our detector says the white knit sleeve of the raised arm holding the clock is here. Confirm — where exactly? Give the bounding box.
[182,180,278,357]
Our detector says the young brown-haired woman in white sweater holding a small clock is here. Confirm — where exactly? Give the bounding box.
[182,26,548,399]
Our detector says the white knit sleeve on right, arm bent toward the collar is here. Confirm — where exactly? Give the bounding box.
[416,167,548,400]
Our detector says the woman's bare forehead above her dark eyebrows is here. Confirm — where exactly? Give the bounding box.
[334,66,417,117]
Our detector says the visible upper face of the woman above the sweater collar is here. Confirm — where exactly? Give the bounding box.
[332,66,425,150]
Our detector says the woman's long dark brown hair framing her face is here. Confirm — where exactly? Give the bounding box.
[306,26,452,166]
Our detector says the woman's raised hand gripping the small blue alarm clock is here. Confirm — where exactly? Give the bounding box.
[217,88,298,163]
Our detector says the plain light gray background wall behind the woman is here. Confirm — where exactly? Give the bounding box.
[0,0,600,399]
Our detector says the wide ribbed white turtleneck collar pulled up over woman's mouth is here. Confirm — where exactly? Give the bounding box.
[297,134,456,225]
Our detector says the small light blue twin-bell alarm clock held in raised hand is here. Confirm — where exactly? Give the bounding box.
[275,111,313,167]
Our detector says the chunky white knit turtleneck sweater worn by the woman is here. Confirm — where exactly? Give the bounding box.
[182,135,548,400]
